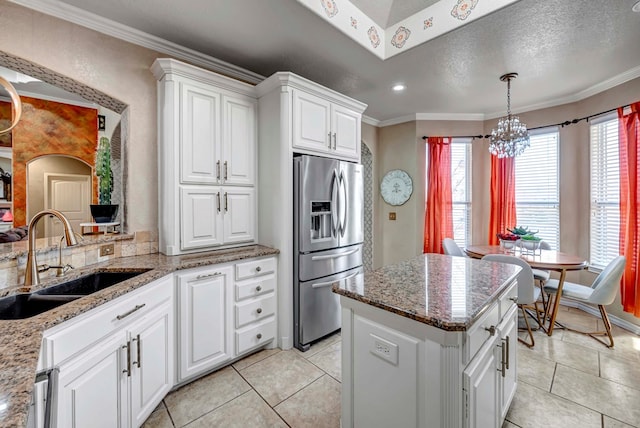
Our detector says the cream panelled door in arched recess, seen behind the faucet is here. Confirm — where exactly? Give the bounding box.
[44,173,91,237]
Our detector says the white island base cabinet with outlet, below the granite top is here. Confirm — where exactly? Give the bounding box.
[340,283,518,428]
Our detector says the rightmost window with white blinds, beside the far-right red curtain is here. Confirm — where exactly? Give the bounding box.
[589,115,620,269]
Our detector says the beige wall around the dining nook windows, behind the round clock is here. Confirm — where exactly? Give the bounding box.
[374,78,640,325]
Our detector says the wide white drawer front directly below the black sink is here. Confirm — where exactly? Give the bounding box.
[43,275,173,367]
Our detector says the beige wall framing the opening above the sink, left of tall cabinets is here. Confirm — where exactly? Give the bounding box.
[0,0,160,232]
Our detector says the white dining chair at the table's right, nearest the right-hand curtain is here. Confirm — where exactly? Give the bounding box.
[544,256,626,348]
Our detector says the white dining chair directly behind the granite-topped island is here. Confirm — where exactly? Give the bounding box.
[482,254,542,348]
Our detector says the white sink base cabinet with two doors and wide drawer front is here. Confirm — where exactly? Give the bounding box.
[44,275,174,428]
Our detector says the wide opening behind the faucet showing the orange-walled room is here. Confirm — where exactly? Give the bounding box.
[0,52,127,241]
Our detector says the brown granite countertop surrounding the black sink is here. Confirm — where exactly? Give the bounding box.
[0,245,279,427]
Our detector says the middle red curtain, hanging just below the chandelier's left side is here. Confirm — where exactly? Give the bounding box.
[489,155,516,245]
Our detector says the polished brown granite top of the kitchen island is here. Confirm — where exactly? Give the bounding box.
[333,254,520,331]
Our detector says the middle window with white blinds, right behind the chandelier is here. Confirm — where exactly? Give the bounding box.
[516,128,560,250]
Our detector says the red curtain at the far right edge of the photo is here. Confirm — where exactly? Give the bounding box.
[618,102,640,317]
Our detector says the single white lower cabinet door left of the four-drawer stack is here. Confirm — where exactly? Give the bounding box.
[178,266,233,381]
